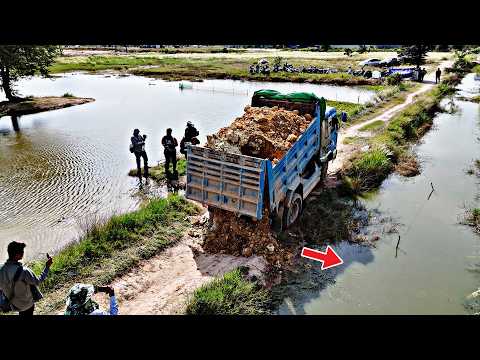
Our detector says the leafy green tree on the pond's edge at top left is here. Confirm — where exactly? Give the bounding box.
[0,45,61,101]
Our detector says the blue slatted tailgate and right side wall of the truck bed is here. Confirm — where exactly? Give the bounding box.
[186,107,336,219]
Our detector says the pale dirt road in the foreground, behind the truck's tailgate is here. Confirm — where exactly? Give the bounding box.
[95,215,267,315]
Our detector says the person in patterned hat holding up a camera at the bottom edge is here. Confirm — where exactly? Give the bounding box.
[65,284,118,315]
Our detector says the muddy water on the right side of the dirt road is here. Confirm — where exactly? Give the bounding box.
[279,75,480,314]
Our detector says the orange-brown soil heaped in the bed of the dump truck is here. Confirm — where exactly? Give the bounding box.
[206,106,312,163]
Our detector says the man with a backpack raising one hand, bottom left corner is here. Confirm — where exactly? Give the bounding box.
[0,241,53,316]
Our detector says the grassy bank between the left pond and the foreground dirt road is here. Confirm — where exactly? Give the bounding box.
[31,195,199,313]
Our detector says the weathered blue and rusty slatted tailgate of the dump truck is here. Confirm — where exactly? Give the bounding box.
[185,146,267,219]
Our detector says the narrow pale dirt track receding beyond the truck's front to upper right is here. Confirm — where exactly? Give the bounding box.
[328,60,453,174]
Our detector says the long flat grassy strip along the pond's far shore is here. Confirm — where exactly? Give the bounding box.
[50,55,378,85]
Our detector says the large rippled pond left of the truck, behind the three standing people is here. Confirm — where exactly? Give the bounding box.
[0,73,373,259]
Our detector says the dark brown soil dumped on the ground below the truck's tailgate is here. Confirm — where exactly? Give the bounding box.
[203,208,294,267]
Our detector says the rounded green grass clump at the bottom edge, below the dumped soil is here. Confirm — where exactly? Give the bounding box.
[186,268,270,315]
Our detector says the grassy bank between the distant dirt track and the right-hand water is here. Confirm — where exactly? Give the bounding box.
[343,83,454,194]
